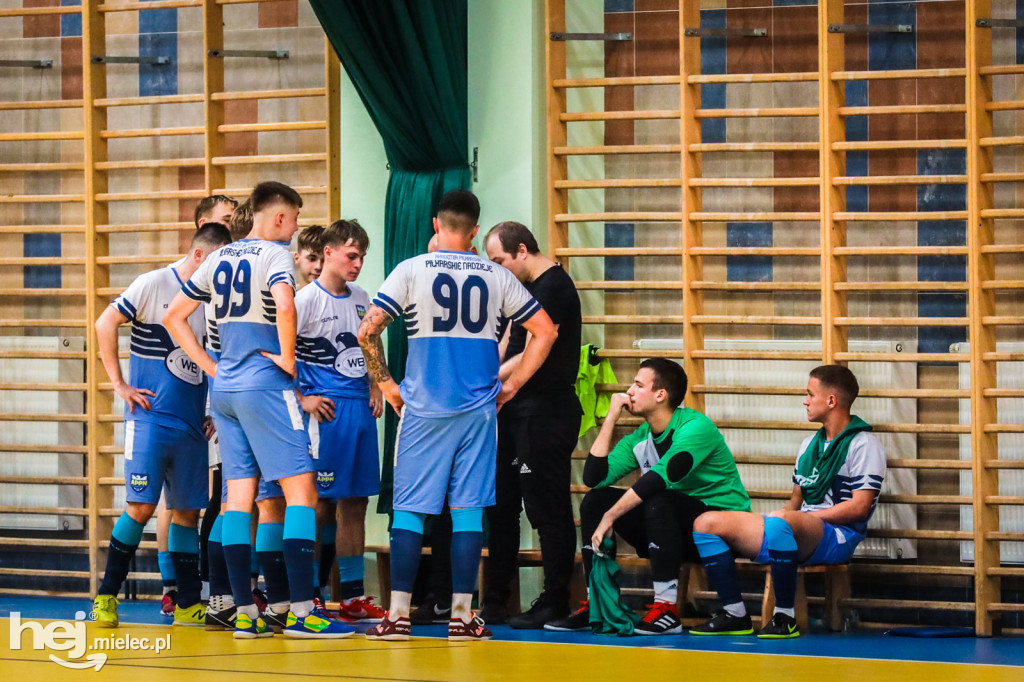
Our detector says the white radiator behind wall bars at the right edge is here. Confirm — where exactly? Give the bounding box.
[949,342,1024,563]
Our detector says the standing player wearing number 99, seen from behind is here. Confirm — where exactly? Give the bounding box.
[165,182,352,639]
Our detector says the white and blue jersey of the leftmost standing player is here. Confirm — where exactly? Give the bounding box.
[111,267,207,434]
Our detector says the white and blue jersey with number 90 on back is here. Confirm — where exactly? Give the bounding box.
[374,251,541,418]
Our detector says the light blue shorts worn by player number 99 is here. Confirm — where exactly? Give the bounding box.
[210,390,313,480]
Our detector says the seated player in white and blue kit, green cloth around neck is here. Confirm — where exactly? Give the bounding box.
[690,365,886,639]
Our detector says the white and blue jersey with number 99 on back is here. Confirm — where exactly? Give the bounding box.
[181,240,295,392]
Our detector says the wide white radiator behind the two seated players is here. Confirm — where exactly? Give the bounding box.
[633,339,918,559]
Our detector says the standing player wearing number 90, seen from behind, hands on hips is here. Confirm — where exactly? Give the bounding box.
[358,189,558,640]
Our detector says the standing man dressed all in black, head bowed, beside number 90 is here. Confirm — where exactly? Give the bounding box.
[480,221,583,629]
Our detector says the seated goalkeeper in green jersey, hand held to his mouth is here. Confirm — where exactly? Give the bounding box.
[544,357,751,635]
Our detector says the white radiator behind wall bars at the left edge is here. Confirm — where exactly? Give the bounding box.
[0,336,85,530]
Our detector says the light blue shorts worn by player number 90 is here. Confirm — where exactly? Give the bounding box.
[394,404,498,514]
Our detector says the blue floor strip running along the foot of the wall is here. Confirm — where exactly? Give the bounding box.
[8,595,1024,668]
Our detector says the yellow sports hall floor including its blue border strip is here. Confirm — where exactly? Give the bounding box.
[6,597,1024,682]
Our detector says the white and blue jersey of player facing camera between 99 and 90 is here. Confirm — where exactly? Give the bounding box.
[295,282,370,399]
